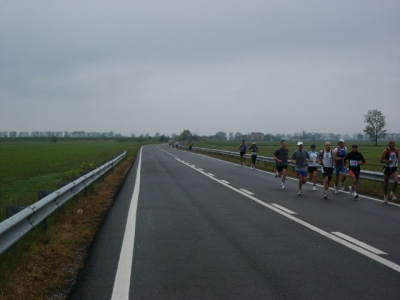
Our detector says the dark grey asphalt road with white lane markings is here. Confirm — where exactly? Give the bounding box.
[69,145,400,300]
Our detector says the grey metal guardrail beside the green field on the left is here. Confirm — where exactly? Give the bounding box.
[0,151,126,254]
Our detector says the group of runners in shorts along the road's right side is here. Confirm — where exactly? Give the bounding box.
[238,139,399,203]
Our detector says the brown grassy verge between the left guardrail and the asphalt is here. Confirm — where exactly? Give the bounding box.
[0,156,134,300]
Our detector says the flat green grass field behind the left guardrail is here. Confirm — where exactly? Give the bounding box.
[0,140,142,221]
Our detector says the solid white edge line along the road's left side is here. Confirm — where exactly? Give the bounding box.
[111,148,143,300]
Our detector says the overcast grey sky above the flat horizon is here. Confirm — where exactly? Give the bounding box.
[0,0,400,135]
